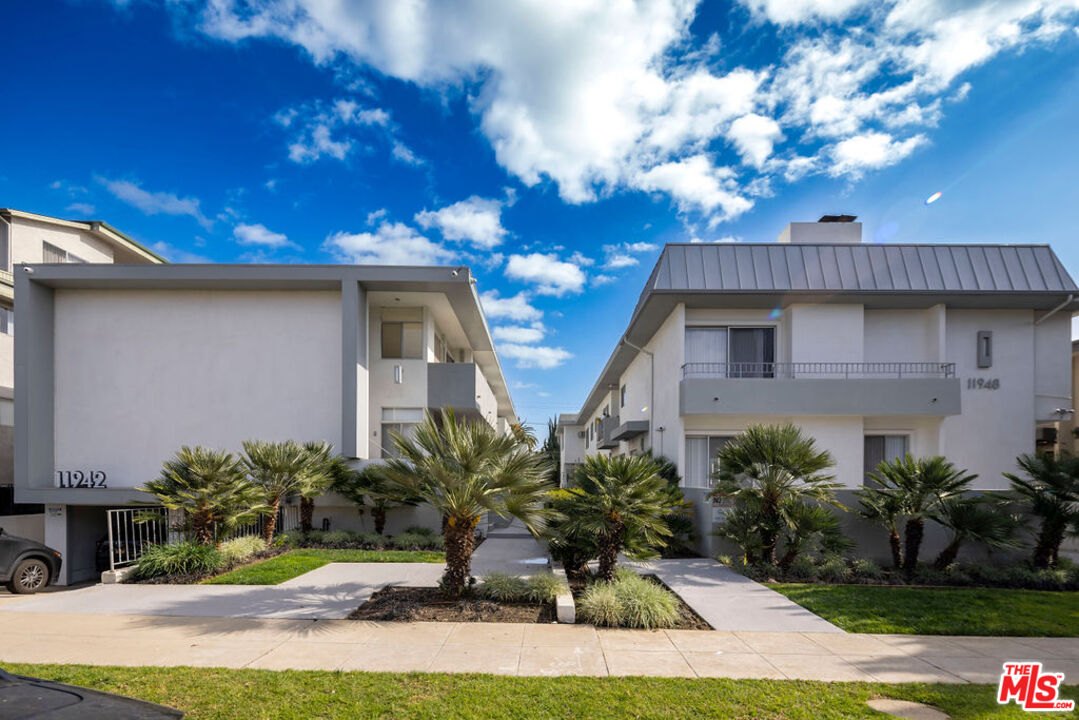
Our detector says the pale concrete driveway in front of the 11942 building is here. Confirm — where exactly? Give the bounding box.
[0,562,445,620]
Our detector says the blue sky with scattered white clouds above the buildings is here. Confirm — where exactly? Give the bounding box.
[0,0,1079,424]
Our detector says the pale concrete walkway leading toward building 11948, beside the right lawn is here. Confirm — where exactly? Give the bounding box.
[633,558,843,633]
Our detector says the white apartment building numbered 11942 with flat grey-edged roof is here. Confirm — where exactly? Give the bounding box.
[15,264,516,583]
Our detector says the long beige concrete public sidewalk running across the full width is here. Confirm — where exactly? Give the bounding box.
[0,608,1079,683]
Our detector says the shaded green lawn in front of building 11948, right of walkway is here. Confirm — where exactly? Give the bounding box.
[768,584,1079,637]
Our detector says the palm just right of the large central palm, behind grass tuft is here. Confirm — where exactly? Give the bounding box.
[563,456,671,581]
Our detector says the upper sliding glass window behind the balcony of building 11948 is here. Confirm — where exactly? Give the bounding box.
[685,327,776,378]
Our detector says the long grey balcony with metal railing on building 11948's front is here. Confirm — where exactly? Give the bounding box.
[679,363,960,416]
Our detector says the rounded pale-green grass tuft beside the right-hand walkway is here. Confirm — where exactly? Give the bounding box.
[579,569,679,628]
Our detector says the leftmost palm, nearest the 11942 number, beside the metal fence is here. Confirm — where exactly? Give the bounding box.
[136,446,270,545]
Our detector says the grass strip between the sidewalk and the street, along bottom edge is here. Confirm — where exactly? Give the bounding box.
[6,665,1079,720]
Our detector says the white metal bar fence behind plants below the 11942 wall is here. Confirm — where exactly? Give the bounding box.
[106,505,300,570]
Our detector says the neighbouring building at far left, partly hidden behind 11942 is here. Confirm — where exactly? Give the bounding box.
[0,208,165,541]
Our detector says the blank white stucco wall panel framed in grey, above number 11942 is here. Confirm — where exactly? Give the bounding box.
[54,289,341,488]
